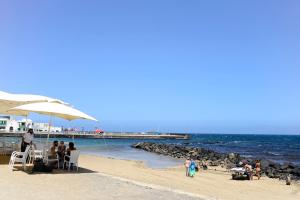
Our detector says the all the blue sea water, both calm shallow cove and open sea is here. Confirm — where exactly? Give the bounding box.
[0,134,300,168]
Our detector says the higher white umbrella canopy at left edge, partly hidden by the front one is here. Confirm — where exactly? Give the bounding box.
[0,91,66,114]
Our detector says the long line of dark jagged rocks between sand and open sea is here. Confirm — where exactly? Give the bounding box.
[132,142,300,180]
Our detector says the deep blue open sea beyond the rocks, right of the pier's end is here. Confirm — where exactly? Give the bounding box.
[185,134,300,165]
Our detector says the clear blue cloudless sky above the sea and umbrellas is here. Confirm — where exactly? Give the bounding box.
[0,0,300,134]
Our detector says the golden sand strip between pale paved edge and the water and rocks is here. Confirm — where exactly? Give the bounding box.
[78,155,300,200]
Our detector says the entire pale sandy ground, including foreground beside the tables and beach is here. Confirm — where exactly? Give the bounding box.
[0,155,300,200]
